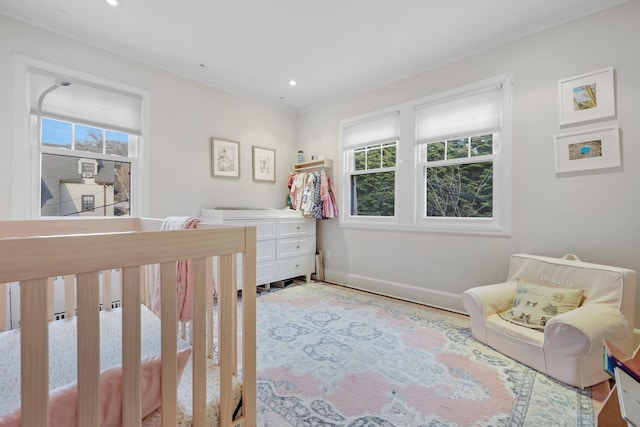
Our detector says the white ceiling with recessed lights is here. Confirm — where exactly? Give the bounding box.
[0,0,627,112]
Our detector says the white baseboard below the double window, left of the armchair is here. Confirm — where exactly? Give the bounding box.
[324,268,466,314]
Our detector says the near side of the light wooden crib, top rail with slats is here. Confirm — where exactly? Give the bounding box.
[0,227,256,427]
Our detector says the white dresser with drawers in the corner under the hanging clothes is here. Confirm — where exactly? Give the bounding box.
[200,208,316,289]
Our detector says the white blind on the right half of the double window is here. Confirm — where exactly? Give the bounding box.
[416,86,502,143]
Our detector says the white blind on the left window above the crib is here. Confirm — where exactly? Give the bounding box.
[28,70,142,135]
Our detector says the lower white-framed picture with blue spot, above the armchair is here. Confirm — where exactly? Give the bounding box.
[554,125,621,173]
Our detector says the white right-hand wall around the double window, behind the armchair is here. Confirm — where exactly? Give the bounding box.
[298,1,640,324]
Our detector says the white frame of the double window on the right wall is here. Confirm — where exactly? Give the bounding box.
[338,73,513,236]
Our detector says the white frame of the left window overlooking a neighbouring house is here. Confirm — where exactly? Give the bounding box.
[11,53,150,219]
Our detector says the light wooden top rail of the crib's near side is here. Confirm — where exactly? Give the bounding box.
[0,227,245,283]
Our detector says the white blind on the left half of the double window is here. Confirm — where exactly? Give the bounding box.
[342,111,399,148]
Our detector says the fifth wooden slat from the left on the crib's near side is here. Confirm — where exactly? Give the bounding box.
[191,258,206,426]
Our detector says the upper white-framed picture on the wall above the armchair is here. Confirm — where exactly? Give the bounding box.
[558,67,616,126]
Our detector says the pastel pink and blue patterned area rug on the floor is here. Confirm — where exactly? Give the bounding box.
[252,283,594,427]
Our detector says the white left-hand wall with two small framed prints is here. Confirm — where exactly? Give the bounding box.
[0,16,298,219]
